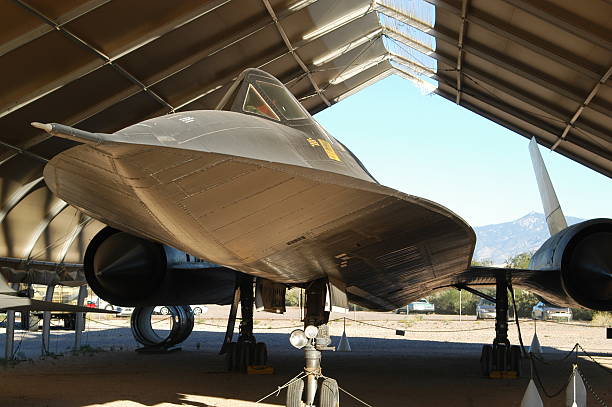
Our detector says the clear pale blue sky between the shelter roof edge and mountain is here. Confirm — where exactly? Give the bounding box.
[315,75,612,226]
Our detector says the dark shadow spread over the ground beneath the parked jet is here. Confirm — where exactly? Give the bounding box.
[0,328,612,407]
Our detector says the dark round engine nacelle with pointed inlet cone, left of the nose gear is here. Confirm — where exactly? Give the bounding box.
[83,227,236,307]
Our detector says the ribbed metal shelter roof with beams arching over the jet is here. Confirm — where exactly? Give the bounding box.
[0,0,612,284]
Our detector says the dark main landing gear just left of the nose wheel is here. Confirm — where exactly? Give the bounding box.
[220,274,268,372]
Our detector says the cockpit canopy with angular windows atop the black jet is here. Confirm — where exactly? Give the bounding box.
[217,69,311,122]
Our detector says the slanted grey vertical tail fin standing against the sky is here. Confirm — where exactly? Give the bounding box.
[529,137,567,236]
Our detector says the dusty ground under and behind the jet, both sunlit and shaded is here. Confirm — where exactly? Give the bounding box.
[0,306,612,407]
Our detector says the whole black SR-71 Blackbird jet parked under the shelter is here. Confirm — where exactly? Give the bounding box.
[28,69,612,405]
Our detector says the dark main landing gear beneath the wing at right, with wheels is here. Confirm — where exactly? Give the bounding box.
[480,270,521,378]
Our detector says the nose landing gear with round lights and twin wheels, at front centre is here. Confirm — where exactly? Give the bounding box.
[285,280,339,407]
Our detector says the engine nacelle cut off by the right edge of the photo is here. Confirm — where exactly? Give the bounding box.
[529,219,612,311]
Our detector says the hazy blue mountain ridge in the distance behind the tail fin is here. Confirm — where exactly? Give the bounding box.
[474,212,584,264]
